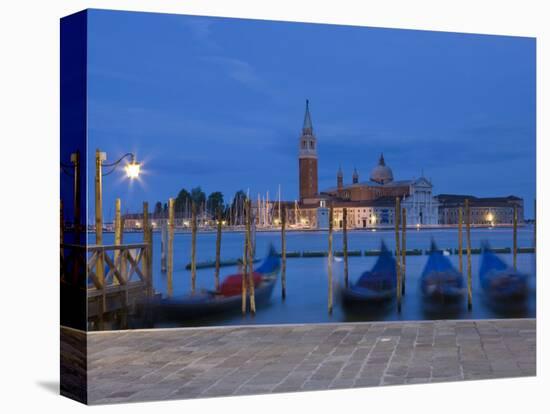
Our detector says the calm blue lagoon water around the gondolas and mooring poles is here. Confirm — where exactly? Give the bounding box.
[98,226,536,328]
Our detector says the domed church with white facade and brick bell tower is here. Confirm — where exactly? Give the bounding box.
[296,101,438,229]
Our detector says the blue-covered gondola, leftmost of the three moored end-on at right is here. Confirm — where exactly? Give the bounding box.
[340,242,397,305]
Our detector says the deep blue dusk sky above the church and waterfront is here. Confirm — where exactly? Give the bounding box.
[88,10,536,221]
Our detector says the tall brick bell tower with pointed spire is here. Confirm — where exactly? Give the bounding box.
[298,100,319,202]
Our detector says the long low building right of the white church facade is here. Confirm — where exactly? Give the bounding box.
[436,194,525,226]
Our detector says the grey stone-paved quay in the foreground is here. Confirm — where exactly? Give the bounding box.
[75,319,536,404]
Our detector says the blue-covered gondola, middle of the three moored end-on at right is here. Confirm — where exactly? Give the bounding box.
[420,240,464,304]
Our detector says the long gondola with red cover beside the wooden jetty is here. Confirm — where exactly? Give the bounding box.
[153,246,281,319]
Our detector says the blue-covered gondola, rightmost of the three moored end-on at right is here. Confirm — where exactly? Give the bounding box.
[479,243,528,304]
